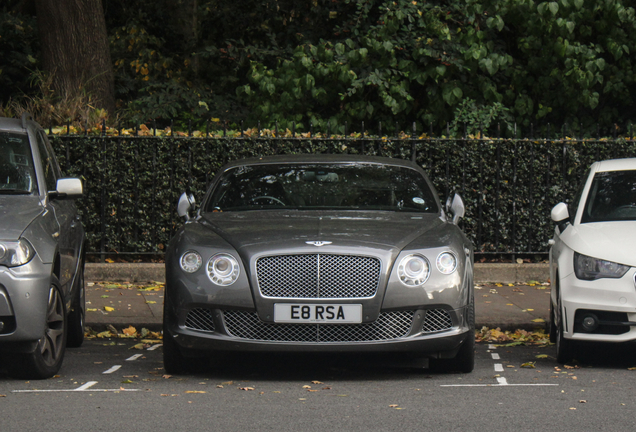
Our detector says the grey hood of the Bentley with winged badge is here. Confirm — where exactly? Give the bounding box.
[202,211,444,253]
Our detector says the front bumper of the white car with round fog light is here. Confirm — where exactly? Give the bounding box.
[560,268,636,342]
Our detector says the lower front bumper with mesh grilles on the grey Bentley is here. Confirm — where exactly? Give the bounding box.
[164,308,472,358]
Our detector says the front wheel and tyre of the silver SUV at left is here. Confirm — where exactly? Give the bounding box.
[9,276,68,379]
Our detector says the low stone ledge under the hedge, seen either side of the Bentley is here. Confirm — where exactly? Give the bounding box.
[84,263,550,284]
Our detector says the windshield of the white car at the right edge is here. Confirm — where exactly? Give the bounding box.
[581,170,636,223]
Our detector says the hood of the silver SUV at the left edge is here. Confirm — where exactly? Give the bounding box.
[0,195,44,240]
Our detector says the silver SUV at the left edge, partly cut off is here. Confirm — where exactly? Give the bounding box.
[0,114,85,379]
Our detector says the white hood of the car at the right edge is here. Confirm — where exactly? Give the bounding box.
[563,221,636,267]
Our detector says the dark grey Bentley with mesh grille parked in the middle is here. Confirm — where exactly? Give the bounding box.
[163,155,475,373]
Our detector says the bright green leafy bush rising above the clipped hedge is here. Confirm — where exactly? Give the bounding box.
[238,0,636,133]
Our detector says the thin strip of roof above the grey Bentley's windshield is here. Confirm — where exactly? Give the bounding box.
[222,154,422,171]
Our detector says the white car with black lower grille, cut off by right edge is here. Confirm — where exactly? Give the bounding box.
[550,158,636,363]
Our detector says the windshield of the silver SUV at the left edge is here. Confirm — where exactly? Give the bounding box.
[0,132,35,194]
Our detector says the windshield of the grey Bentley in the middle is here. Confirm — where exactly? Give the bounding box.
[205,163,439,213]
